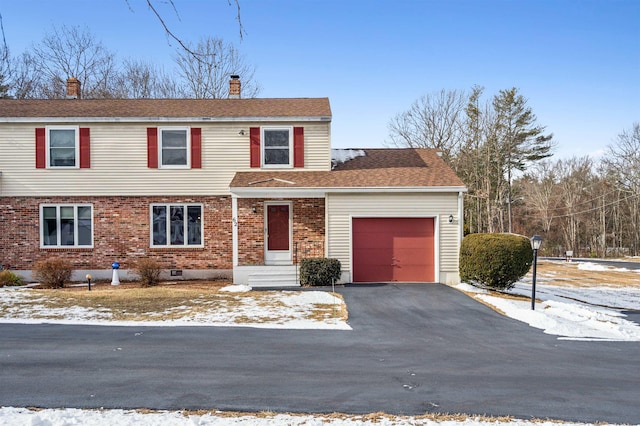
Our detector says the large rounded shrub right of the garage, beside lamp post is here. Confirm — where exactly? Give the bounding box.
[460,234,533,290]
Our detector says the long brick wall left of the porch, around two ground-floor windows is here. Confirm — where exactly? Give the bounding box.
[0,196,232,270]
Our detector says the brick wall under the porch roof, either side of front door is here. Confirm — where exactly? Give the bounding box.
[238,198,325,266]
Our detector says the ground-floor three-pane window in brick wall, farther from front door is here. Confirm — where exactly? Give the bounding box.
[40,204,93,248]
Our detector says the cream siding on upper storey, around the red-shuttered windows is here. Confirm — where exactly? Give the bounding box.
[0,122,331,196]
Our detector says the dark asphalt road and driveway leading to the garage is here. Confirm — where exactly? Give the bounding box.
[0,285,640,423]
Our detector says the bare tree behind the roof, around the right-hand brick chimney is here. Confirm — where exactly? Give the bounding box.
[175,37,260,99]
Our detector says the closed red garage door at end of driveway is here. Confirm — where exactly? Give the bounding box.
[352,218,435,282]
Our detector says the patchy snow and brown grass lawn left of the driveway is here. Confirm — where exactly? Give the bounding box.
[0,285,351,330]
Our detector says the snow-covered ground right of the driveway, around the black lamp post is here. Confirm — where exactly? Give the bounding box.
[456,261,640,341]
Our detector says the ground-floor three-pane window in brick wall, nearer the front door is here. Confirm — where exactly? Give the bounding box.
[151,204,203,247]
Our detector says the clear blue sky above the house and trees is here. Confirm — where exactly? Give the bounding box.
[0,0,640,158]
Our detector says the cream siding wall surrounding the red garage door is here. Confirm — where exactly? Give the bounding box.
[326,192,460,281]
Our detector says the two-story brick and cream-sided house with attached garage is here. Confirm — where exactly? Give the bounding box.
[0,76,466,286]
